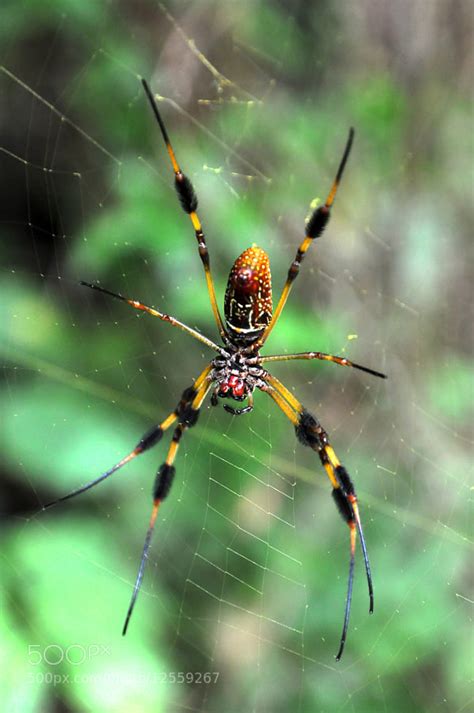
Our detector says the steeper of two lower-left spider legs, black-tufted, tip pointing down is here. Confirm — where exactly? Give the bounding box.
[122,369,212,636]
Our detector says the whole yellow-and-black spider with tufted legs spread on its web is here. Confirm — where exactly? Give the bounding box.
[43,79,386,661]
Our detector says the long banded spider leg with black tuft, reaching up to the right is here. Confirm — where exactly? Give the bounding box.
[252,127,354,350]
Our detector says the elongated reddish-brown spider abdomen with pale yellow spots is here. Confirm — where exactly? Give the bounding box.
[224,245,273,344]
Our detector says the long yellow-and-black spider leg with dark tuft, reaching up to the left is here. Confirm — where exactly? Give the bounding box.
[142,79,227,342]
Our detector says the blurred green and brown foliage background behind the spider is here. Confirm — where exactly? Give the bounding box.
[0,0,473,713]
